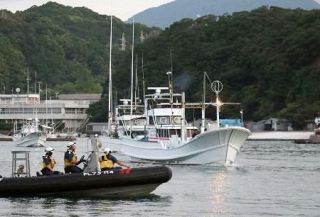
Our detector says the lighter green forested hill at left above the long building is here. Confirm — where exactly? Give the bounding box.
[0,2,158,93]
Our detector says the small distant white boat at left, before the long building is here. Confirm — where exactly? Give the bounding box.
[13,119,47,147]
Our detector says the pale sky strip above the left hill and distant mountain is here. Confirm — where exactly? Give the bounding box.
[0,0,175,21]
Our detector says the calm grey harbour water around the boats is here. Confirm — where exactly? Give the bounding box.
[0,139,320,217]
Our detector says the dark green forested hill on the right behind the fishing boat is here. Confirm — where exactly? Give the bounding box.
[132,7,320,127]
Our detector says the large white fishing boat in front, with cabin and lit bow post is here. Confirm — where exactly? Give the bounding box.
[114,76,251,165]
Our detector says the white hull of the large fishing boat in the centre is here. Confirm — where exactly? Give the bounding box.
[121,127,251,164]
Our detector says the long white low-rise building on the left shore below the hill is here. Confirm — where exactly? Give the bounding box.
[0,94,101,132]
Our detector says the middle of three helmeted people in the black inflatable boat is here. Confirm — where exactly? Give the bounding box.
[64,142,83,173]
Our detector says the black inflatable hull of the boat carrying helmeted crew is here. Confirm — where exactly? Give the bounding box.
[0,166,172,197]
